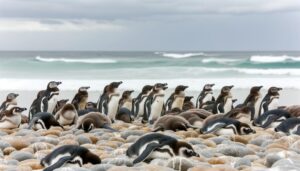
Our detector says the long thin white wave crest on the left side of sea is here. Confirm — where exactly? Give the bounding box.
[35,56,117,64]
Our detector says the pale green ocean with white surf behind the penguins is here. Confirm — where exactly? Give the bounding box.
[0,51,300,107]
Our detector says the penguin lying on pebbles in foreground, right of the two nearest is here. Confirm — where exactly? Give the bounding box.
[126,133,199,164]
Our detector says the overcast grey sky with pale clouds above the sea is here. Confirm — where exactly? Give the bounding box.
[0,0,300,51]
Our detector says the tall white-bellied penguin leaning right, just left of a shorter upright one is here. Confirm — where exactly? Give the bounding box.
[97,81,123,121]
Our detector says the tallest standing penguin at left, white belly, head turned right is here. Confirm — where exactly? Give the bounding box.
[28,81,61,120]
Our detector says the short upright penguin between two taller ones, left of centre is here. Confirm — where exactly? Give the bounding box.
[116,90,134,123]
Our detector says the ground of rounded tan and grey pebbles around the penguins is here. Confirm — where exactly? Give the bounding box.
[0,122,300,171]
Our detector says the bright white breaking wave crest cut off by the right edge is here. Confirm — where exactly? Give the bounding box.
[250,55,300,63]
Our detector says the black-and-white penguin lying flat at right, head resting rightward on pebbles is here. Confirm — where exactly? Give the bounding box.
[200,117,255,135]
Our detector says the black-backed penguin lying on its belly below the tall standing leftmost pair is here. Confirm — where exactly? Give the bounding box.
[28,112,64,130]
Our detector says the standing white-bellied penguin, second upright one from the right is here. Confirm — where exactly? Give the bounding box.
[243,86,263,120]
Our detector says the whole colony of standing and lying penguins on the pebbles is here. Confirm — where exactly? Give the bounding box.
[0,81,300,171]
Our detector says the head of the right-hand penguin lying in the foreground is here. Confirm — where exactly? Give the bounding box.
[175,141,200,158]
